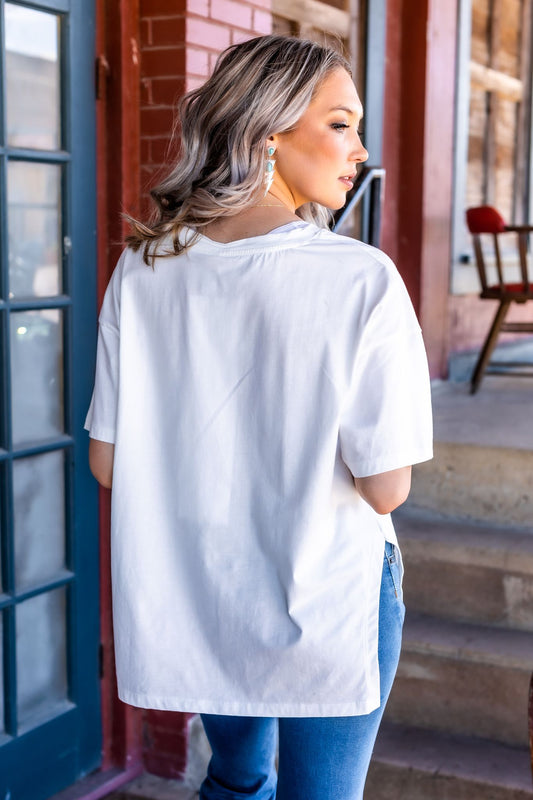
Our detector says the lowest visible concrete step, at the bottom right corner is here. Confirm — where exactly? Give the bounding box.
[364,723,533,800]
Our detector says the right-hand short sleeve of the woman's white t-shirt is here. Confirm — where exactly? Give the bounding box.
[340,254,433,478]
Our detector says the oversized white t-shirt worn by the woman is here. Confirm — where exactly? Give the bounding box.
[86,222,432,717]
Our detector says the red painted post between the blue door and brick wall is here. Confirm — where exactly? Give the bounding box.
[96,0,142,774]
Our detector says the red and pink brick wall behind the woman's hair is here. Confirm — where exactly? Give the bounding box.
[140,0,272,213]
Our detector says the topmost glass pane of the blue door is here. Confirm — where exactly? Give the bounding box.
[5,3,61,150]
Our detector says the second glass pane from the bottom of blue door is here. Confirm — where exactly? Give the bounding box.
[13,451,65,592]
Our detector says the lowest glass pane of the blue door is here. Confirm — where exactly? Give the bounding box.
[15,588,67,728]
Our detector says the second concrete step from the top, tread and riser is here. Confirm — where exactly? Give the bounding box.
[394,509,533,632]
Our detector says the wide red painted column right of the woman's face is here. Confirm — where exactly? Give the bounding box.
[382,0,457,376]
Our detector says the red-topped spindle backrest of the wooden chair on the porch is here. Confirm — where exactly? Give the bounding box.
[466,206,533,293]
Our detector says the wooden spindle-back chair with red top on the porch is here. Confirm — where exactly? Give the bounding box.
[466,206,533,394]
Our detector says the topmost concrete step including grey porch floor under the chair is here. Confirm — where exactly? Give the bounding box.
[411,376,533,532]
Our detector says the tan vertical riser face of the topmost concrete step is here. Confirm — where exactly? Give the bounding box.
[409,441,533,528]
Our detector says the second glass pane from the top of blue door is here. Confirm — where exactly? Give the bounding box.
[7,161,61,298]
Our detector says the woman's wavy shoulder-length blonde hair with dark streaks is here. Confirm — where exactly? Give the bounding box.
[126,35,350,264]
